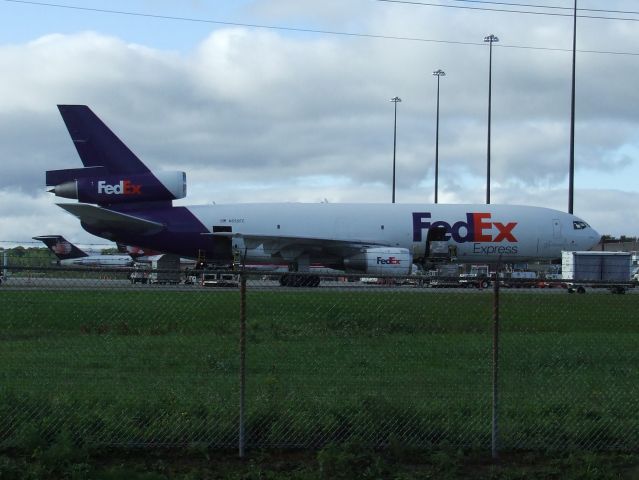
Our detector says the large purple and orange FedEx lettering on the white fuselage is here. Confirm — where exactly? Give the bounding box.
[413,212,518,243]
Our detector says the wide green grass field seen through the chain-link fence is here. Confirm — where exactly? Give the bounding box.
[0,289,639,450]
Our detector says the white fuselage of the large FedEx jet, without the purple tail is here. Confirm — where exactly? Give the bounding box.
[188,203,600,262]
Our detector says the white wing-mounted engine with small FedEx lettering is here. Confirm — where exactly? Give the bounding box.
[344,247,413,276]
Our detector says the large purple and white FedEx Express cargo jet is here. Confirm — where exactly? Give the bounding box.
[46,105,600,286]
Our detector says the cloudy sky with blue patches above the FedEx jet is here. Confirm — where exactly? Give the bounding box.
[0,0,639,246]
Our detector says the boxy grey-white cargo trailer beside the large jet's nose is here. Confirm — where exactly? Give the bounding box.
[561,251,632,293]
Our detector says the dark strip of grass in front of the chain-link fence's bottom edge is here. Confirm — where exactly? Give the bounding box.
[0,448,639,480]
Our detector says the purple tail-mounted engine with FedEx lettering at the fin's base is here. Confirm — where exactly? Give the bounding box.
[47,167,186,205]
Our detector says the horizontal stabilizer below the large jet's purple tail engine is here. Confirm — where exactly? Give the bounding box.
[57,203,164,235]
